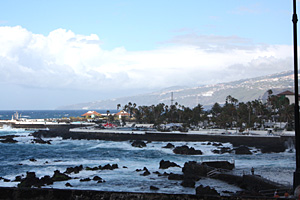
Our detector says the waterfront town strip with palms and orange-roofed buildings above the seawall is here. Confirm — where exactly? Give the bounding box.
[0,90,294,135]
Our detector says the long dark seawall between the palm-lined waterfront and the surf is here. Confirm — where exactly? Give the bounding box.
[33,129,295,152]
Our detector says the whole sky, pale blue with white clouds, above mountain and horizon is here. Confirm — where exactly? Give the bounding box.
[0,0,300,110]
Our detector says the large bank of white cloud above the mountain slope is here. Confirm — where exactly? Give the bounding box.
[0,26,292,94]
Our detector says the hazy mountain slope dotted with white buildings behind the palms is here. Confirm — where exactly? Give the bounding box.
[57,71,294,110]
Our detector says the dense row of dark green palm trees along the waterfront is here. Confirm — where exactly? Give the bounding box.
[118,91,294,130]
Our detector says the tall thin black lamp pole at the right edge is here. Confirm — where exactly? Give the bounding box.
[292,0,300,189]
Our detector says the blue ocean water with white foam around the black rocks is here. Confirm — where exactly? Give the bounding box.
[0,110,296,194]
